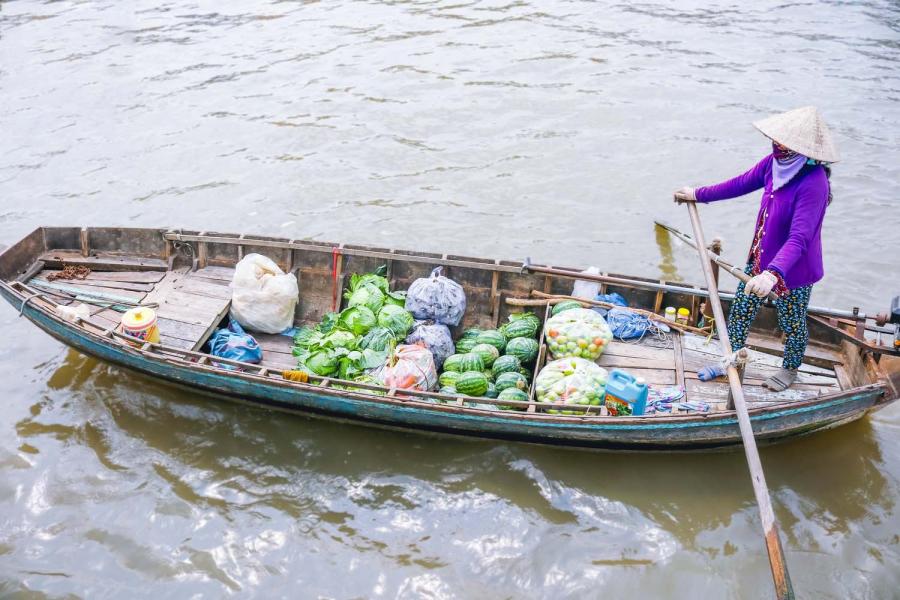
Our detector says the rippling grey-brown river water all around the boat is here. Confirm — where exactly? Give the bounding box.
[0,0,900,598]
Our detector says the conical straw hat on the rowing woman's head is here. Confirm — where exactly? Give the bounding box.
[753,106,840,162]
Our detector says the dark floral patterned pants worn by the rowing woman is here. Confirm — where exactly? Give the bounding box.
[728,265,812,369]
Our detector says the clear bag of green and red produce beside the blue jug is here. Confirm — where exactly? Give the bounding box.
[534,356,608,414]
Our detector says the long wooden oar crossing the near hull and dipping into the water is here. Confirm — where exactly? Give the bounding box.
[686,202,794,599]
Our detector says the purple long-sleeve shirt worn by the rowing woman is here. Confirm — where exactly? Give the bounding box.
[695,154,828,290]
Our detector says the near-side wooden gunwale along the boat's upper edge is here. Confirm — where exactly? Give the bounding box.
[0,281,887,430]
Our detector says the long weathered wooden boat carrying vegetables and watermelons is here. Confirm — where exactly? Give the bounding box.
[0,227,900,450]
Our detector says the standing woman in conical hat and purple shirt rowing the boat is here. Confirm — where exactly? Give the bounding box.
[675,106,838,391]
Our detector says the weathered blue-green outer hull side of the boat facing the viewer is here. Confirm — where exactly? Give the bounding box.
[0,286,884,451]
